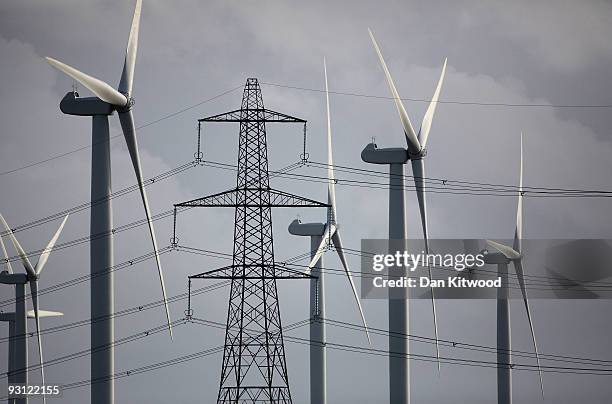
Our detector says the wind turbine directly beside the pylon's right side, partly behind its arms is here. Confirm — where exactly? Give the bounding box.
[289,59,371,404]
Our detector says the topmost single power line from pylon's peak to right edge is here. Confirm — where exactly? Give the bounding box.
[261,82,612,109]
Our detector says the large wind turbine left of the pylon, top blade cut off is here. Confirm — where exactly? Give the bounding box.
[46,0,172,404]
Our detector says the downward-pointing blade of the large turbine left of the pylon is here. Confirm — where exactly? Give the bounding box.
[119,110,172,338]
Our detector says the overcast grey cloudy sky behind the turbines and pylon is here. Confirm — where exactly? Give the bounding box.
[0,0,612,404]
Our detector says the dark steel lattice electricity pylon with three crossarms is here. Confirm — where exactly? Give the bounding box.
[175,78,327,404]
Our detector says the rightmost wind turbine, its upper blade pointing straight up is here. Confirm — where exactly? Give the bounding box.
[484,133,544,404]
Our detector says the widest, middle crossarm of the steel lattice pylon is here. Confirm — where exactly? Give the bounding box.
[174,188,329,208]
